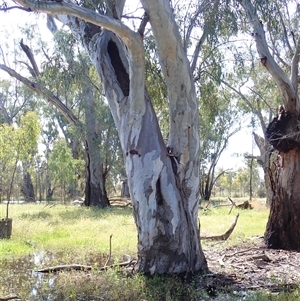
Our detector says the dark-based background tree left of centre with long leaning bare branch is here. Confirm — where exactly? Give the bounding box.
[0,28,116,207]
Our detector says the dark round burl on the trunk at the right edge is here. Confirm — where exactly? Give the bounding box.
[266,107,300,153]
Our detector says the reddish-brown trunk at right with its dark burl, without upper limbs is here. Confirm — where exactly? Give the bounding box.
[265,111,300,251]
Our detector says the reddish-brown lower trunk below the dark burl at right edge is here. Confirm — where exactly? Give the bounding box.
[265,149,300,251]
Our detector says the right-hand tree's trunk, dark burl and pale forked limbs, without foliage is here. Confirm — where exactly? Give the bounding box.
[238,0,300,251]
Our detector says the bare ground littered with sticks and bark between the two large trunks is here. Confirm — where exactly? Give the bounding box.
[203,237,300,294]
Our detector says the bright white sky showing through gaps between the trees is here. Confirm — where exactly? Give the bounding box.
[0,0,259,170]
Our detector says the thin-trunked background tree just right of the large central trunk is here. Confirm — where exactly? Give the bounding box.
[200,77,240,200]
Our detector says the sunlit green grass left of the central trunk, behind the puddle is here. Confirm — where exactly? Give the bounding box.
[0,204,137,258]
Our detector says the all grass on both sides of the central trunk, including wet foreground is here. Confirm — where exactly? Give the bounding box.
[0,198,299,301]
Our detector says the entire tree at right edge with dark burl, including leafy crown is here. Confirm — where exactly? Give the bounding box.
[237,0,300,250]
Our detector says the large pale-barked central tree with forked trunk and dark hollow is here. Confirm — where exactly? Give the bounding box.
[11,0,206,274]
